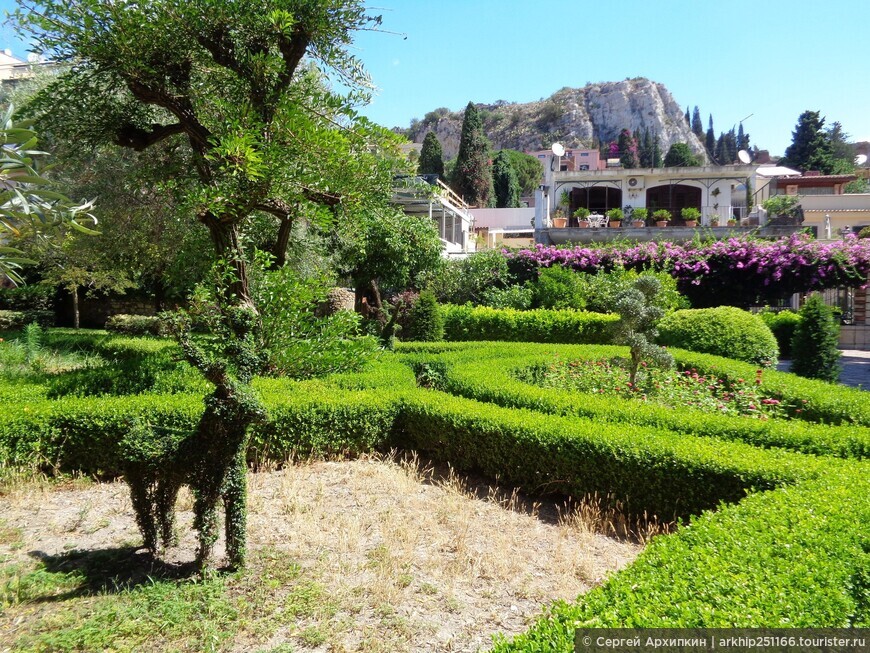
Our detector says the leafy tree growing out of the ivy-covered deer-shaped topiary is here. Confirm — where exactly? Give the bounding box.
[15,0,398,567]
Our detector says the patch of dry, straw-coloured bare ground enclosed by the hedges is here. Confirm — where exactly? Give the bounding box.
[0,458,642,652]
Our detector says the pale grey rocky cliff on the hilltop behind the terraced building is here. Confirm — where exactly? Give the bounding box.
[406,77,705,159]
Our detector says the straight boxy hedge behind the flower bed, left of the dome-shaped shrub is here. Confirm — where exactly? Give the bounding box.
[441,304,619,344]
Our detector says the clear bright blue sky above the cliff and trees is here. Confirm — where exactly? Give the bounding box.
[0,0,870,154]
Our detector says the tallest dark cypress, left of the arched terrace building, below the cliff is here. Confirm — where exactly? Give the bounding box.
[451,102,493,207]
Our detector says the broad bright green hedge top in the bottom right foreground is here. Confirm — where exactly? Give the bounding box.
[493,463,870,653]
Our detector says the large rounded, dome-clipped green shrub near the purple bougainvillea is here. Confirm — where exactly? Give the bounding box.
[658,306,778,367]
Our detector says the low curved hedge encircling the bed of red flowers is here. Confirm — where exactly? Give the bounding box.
[399,343,870,458]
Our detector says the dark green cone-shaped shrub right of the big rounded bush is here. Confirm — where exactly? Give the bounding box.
[791,295,842,382]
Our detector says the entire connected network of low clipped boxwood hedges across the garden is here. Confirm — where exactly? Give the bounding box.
[0,336,870,632]
